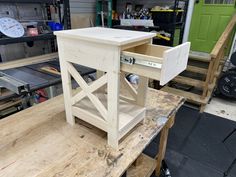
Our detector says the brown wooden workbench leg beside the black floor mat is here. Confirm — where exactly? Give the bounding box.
[156,116,175,176]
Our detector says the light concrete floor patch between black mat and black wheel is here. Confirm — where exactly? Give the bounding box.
[204,97,236,121]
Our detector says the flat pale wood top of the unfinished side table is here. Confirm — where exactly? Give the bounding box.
[54,27,156,46]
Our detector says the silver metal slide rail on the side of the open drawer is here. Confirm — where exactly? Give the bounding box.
[120,55,162,69]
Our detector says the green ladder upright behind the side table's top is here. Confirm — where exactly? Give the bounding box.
[96,0,112,28]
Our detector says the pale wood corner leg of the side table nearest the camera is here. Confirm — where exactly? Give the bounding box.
[107,50,120,149]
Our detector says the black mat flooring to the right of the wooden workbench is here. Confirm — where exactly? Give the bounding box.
[144,106,236,177]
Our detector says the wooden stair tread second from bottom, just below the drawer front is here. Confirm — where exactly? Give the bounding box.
[173,76,205,89]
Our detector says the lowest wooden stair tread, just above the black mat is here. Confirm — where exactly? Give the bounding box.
[161,86,207,104]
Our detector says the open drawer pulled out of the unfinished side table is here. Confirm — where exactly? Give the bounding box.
[121,42,190,85]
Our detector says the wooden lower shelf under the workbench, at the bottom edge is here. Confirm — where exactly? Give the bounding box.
[126,154,156,177]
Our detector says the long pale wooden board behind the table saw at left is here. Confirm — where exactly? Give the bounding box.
[0,53,58,70]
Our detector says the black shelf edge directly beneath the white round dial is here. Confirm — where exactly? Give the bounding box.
[0,33,56,45]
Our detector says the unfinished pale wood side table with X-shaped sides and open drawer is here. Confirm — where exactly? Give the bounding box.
[55,27,190,148]
